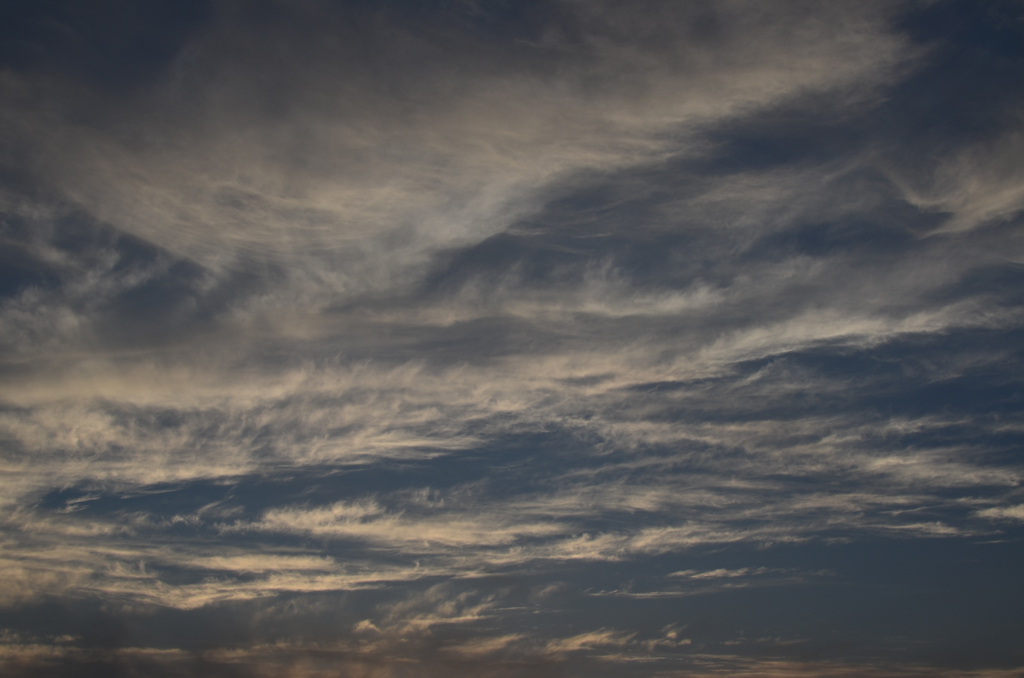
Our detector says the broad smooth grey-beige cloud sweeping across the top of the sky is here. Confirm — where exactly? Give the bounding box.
[2,4,913,282]
